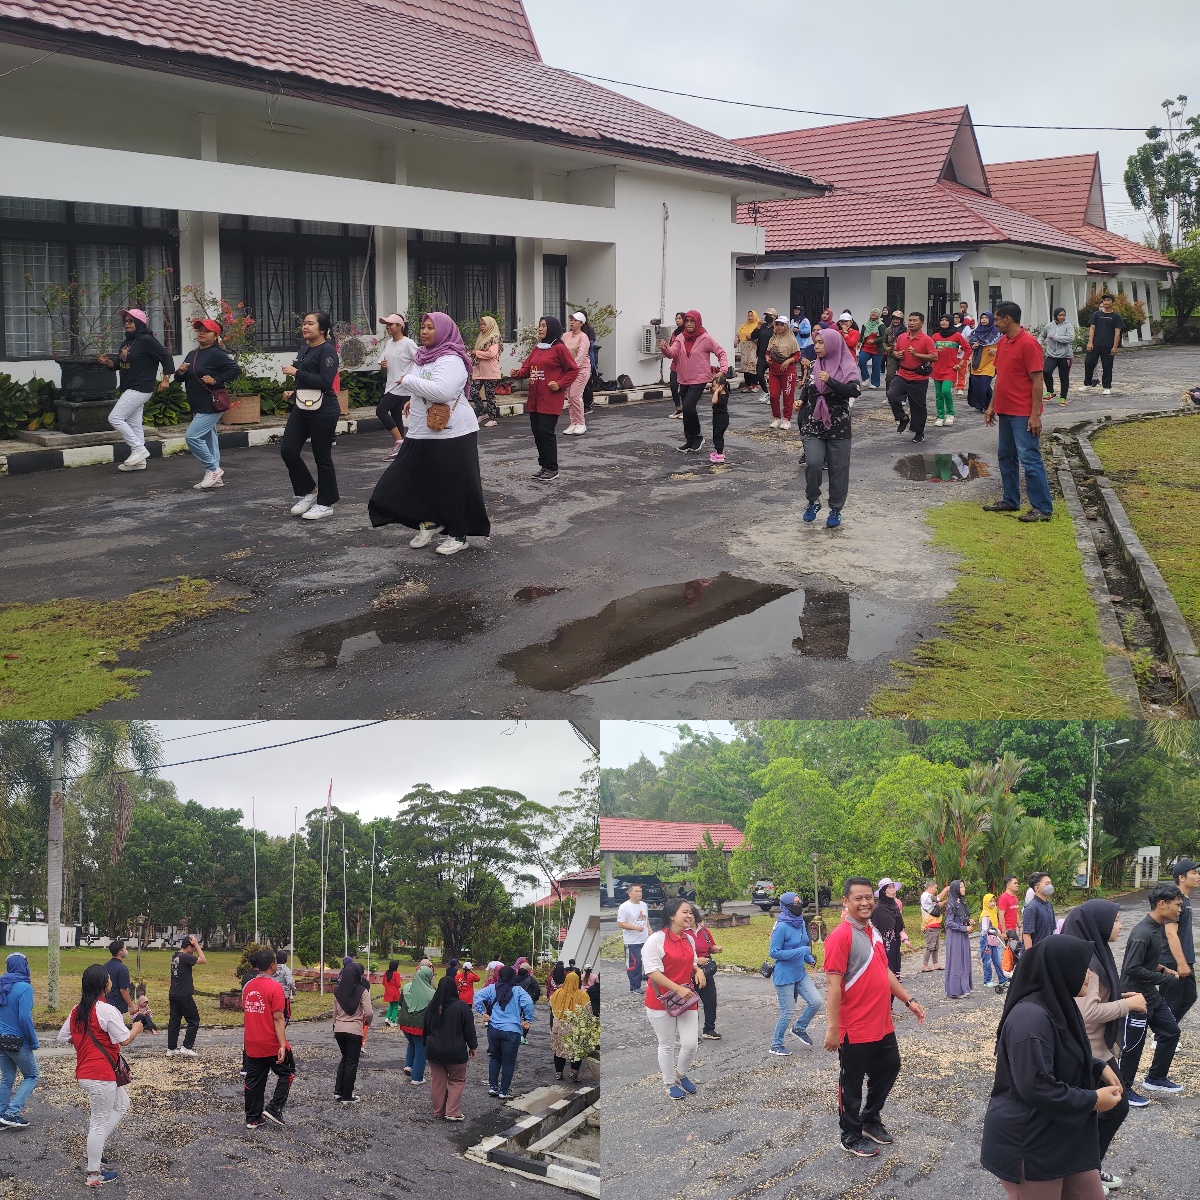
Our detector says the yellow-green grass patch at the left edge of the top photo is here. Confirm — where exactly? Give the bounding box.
[0,578,234,719]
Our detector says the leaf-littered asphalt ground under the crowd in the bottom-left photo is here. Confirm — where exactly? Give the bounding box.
[0,1014,576,1200]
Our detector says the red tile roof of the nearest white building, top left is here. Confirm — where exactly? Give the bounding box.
[0,0,810,192]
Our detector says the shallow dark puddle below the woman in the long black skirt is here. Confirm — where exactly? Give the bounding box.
[295,592,487,670]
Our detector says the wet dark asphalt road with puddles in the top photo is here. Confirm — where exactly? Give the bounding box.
[0,349,1200,719]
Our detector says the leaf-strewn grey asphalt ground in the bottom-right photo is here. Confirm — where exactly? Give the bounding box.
[601,895,1200,1200]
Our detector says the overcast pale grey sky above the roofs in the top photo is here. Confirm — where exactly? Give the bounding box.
[524,0,1200,240]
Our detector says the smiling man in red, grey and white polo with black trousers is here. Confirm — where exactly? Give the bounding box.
[824,876,925,1158]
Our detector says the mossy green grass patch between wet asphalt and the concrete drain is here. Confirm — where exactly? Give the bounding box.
[869,500,1126,720]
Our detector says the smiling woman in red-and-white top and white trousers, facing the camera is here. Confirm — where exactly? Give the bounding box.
[642,896,704,1100]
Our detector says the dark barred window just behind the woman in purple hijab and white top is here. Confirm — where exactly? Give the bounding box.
[408,229,517,341]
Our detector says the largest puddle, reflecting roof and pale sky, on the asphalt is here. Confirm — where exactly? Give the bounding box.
[499,572,906,696]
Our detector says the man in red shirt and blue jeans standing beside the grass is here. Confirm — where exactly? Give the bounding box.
[983,300,1054,521]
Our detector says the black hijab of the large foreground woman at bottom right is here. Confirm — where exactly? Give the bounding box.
[996,934,1094,1087]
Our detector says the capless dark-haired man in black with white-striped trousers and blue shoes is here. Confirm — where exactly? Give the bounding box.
[1121,883,1183,1109]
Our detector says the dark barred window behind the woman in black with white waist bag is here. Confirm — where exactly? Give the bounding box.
[220,214,376,350]
